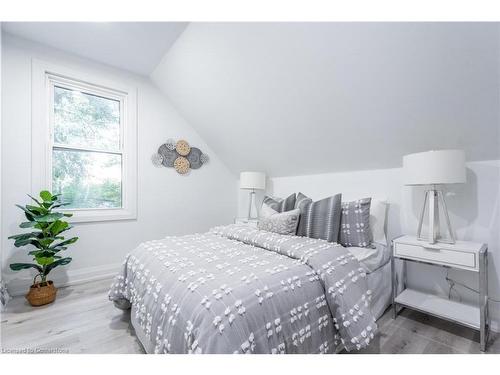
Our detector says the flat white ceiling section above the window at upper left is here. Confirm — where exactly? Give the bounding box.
[2,22,187,75]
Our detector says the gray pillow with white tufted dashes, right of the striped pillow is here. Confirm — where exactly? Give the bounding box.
[340,198,373,247]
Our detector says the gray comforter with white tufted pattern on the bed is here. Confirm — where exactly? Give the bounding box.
[109,225,376,353]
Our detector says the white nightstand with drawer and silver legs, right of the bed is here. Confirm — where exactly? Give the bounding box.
[391,236,490,351]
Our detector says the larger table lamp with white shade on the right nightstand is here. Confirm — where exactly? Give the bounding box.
[403,150,466,244]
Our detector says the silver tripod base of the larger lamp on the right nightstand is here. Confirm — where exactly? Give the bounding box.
[417,189,456,244]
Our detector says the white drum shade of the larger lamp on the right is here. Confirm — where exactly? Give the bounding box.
[403,150,466,185]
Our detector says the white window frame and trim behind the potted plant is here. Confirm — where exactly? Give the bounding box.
[31,59,137,223]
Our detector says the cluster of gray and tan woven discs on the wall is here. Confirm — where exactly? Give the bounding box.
[151,138,209,175]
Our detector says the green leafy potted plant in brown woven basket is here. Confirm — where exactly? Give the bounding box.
[9,190,78,306]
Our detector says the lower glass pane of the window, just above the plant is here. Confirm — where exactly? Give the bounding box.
[52,149,122,208]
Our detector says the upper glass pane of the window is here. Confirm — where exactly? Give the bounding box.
[54,86,120,150]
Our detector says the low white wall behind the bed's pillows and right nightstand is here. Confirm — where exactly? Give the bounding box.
[254,160,500,330]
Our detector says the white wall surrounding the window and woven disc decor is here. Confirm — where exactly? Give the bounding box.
[0,34,236,293]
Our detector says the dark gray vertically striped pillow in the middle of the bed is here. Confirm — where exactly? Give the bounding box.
[295,193,342,242]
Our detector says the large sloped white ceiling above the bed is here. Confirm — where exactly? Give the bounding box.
[152,23,500,176]
